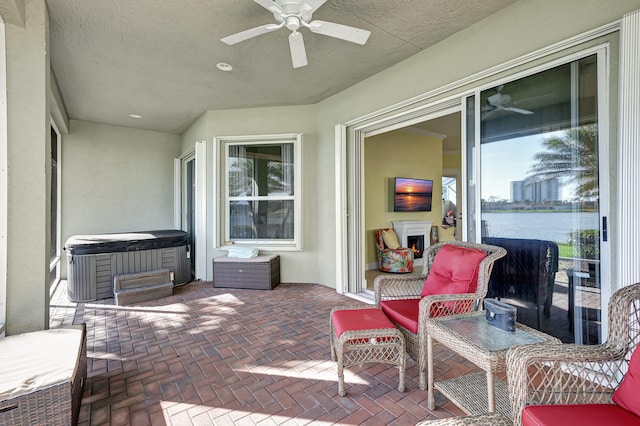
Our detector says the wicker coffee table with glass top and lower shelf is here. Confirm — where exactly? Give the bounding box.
[427,311,560,418]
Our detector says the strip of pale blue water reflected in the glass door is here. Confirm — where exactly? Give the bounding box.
[482,212,599,243]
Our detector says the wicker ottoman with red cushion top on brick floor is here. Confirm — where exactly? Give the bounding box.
[329,306,406,396]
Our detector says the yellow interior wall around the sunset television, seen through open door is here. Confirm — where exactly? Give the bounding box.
[364,130,442,269]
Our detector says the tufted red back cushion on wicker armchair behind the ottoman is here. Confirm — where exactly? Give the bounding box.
[420,244,487,297]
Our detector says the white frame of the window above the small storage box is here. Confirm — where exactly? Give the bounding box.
[215,133,302,251]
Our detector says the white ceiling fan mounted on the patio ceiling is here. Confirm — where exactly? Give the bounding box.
[220,0,371,68]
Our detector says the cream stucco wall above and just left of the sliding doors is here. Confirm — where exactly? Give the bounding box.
[315,0,640,290]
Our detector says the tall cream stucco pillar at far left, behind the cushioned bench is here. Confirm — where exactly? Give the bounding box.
[5,1,51,335]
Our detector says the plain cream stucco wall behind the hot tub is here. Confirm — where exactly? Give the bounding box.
[61,120,180,277]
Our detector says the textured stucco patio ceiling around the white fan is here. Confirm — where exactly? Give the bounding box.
[47,0,516,133]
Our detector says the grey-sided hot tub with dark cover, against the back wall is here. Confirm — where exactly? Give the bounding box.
[64,230,191,302]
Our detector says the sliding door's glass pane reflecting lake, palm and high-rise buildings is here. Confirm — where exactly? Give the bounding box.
[468,55,606,344]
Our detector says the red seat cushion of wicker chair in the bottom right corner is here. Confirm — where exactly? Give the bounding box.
[522,404,640,426]
